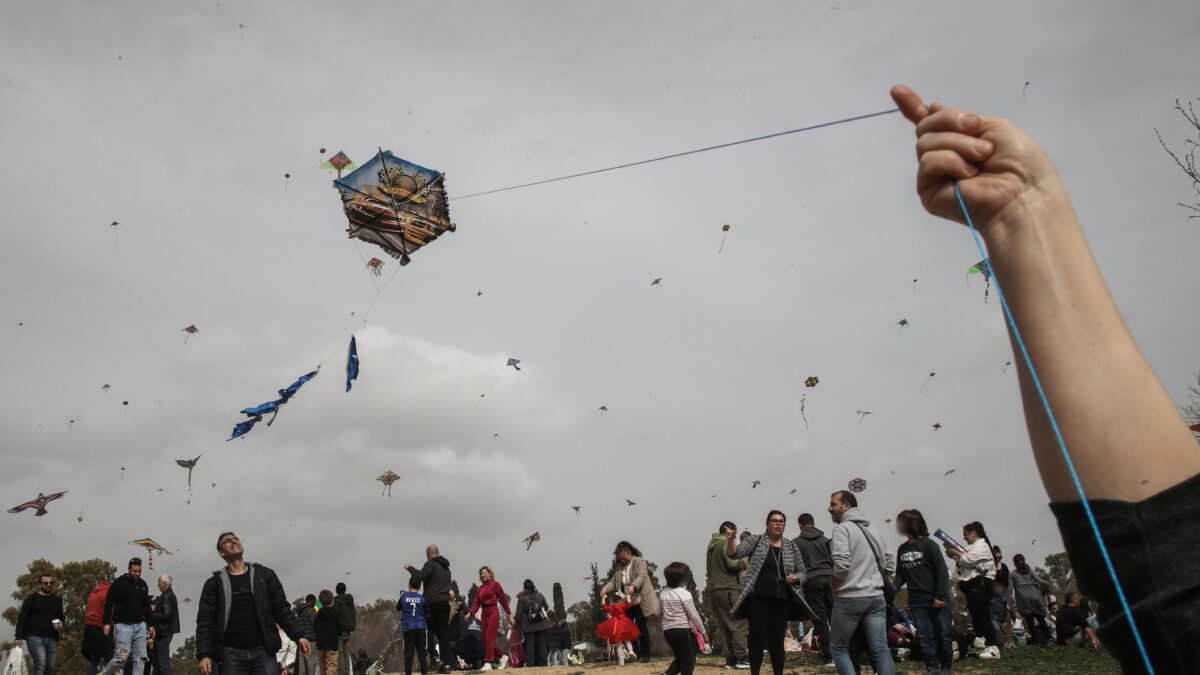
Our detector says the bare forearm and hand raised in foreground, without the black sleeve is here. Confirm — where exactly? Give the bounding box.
[892,85,1200,502]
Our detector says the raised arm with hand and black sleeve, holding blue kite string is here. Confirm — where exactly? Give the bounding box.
[892,85,1200,673]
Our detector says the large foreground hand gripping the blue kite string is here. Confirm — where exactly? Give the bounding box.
[892,84,1066,234]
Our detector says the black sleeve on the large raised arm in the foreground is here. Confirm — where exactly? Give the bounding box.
[1050,476,1200,673]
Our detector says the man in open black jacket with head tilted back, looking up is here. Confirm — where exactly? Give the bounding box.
[196,532,312,675]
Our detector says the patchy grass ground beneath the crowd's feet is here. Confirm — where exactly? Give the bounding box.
[539,646,1121,675]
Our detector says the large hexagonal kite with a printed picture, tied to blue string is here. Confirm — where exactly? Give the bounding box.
[334,149,455,265]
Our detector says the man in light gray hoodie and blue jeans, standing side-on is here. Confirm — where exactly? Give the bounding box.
[829,490,896,675]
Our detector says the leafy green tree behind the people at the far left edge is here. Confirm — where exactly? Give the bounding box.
[2,558,116,673]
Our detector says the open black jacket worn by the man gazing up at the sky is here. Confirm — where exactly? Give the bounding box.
[196,562,305,662]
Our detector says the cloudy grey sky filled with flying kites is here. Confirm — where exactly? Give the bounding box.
[0,0,1200,634]
